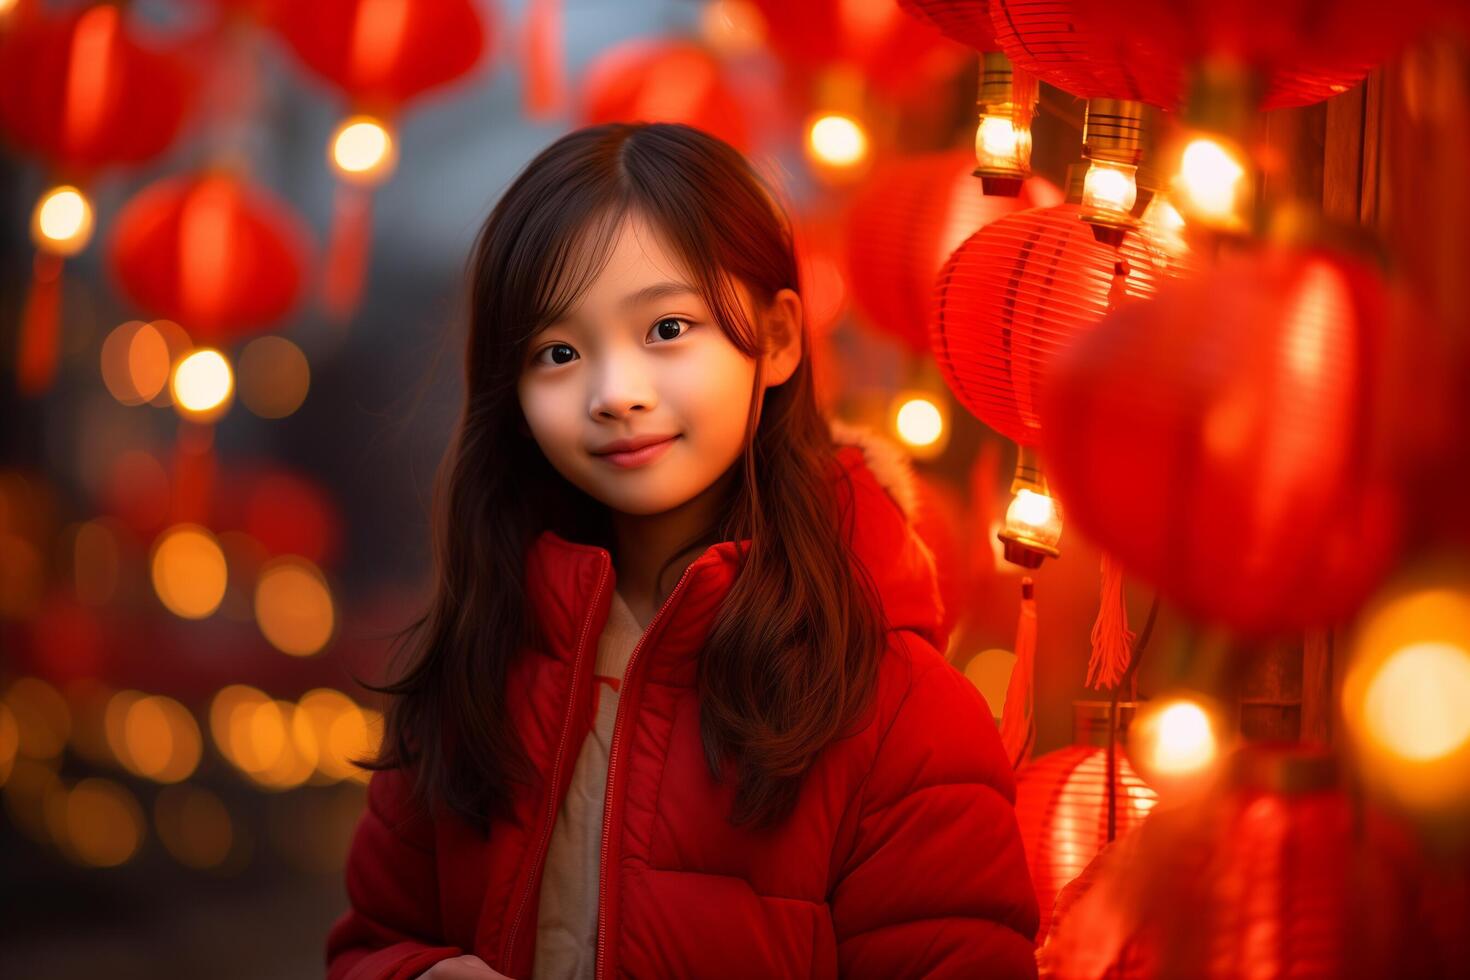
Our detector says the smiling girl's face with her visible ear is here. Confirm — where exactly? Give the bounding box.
[517,215,800,516]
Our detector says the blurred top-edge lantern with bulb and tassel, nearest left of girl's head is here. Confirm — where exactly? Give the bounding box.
[272,0,488,317]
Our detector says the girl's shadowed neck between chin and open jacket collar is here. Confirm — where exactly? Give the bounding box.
[612,467,735,627]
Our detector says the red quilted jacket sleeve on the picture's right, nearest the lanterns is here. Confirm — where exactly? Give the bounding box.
[831,632,1038,977]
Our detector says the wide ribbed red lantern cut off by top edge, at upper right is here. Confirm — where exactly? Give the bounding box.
[991,0,1419,109]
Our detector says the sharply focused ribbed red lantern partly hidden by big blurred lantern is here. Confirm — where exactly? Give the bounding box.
[931,204,1170,445]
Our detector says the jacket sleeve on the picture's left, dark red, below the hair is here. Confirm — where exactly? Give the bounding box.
[326,770,465,980]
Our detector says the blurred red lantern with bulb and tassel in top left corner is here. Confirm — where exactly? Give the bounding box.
[0,3,188,395]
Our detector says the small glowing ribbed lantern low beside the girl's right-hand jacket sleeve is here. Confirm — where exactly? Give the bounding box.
[1016,745,1158,939]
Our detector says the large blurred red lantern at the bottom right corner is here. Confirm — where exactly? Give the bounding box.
[1038,745,1440,979]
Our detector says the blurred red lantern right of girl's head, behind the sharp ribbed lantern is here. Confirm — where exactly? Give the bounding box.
[847,150,1061,354]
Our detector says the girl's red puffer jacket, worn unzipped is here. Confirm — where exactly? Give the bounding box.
[326,437,1036,980]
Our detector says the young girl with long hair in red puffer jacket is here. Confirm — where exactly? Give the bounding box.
[326,125,1036,980]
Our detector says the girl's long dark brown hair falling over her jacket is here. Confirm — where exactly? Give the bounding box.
[365,123,883,833]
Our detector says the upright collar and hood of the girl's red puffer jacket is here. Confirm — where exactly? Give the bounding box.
[526,425,948,683]
